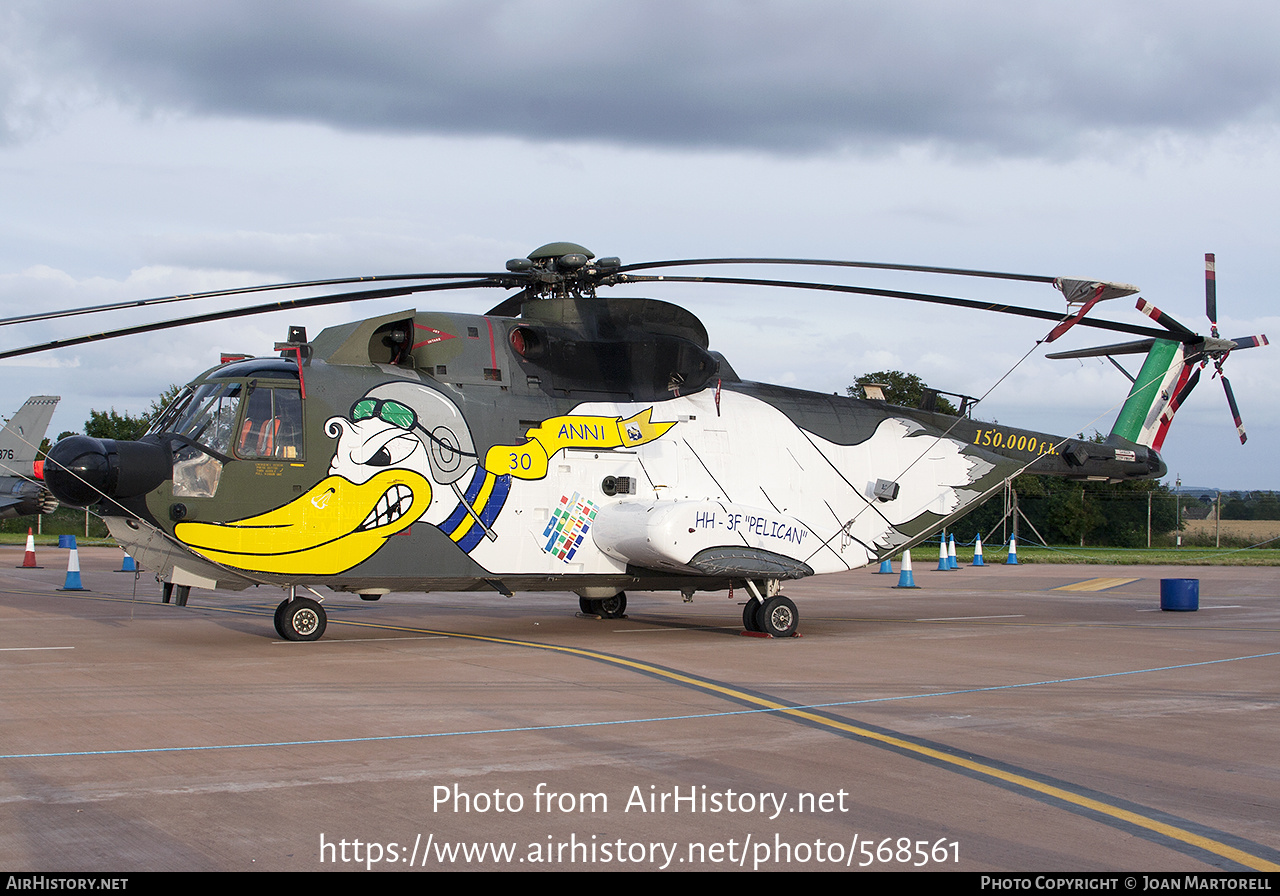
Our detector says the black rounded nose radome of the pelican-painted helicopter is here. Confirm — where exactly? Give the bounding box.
[45,435,173,507]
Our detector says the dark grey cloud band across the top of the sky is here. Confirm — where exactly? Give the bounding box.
[9,0,1280,155]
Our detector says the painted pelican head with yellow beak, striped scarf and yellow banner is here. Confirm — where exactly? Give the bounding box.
[174,383,675,576]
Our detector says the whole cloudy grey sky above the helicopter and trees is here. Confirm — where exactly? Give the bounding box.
[0,0,1280,489]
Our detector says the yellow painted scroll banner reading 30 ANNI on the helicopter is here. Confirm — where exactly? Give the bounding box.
[484,407,676,479]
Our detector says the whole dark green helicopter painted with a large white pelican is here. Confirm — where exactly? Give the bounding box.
[35,243,1266,640]
